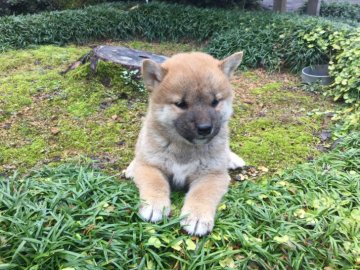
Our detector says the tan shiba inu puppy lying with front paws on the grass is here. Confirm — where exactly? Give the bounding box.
[126,52,245,236]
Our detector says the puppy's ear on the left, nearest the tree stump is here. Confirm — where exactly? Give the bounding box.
[141,59,166,92]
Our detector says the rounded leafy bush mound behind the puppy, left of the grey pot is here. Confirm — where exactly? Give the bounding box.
[207,13,350,72]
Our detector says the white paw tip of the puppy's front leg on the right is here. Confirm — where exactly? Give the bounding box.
[180,214,214,236]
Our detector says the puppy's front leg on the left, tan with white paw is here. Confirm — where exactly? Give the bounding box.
[133,163,170,222]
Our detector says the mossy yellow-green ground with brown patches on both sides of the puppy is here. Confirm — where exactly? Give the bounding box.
[0,41,332,175]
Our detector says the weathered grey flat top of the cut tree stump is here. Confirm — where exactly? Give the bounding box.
[90,45,167,72]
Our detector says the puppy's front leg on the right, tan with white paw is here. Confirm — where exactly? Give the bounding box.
[181,173,230,236]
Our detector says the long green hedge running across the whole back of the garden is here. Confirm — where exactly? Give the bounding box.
[0,3,360,124]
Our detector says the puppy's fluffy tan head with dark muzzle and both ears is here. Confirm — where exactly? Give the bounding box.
[142,52,243,144]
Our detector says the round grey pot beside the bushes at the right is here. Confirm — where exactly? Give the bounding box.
[301,65,333,85]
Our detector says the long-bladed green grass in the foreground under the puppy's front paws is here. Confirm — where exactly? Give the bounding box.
[0,133,360,269]
